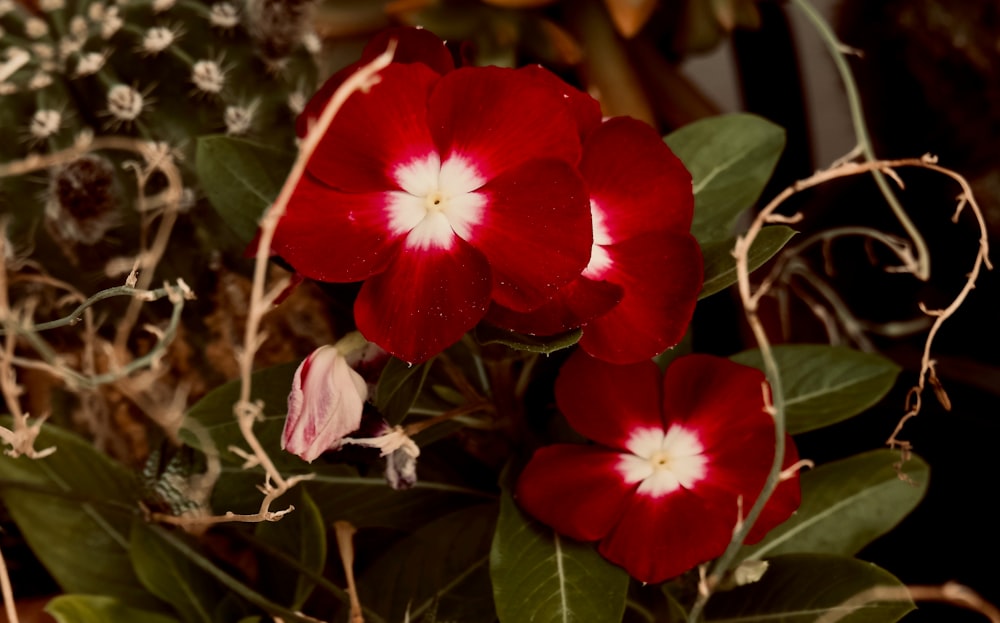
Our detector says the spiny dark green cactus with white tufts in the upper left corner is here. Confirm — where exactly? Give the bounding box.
[0,0,318,289]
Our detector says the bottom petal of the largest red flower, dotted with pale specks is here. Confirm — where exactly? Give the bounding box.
[354,238,493,363]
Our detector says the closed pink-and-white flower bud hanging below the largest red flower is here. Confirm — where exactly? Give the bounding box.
[281,346,368,463]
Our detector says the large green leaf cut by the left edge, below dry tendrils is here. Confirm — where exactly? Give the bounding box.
[0,417,164,610]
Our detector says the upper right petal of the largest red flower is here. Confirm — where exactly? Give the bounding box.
[428,67,580,179]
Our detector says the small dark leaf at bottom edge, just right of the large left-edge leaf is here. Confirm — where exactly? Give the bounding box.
[130,519,225,623]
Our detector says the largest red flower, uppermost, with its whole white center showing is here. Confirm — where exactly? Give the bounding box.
[272,30,593,362]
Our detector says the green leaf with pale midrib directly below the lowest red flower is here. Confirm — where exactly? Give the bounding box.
[490,476,628,623]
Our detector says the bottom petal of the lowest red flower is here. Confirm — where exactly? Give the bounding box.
[599,489,737,583]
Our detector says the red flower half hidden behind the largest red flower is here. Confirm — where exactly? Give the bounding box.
[487,85,703,363]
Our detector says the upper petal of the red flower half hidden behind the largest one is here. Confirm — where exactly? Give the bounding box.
[580,117,694,244]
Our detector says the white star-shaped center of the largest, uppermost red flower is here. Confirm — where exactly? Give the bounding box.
[388,153,486,249]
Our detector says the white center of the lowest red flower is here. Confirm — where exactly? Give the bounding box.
[618,424,708,497]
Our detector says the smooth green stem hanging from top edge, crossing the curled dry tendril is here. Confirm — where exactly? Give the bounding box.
[792,0,931,281]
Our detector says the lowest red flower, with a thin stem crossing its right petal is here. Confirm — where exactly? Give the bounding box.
[517,352,799,582]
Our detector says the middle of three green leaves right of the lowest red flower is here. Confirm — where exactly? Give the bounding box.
[740,450,930,559]
